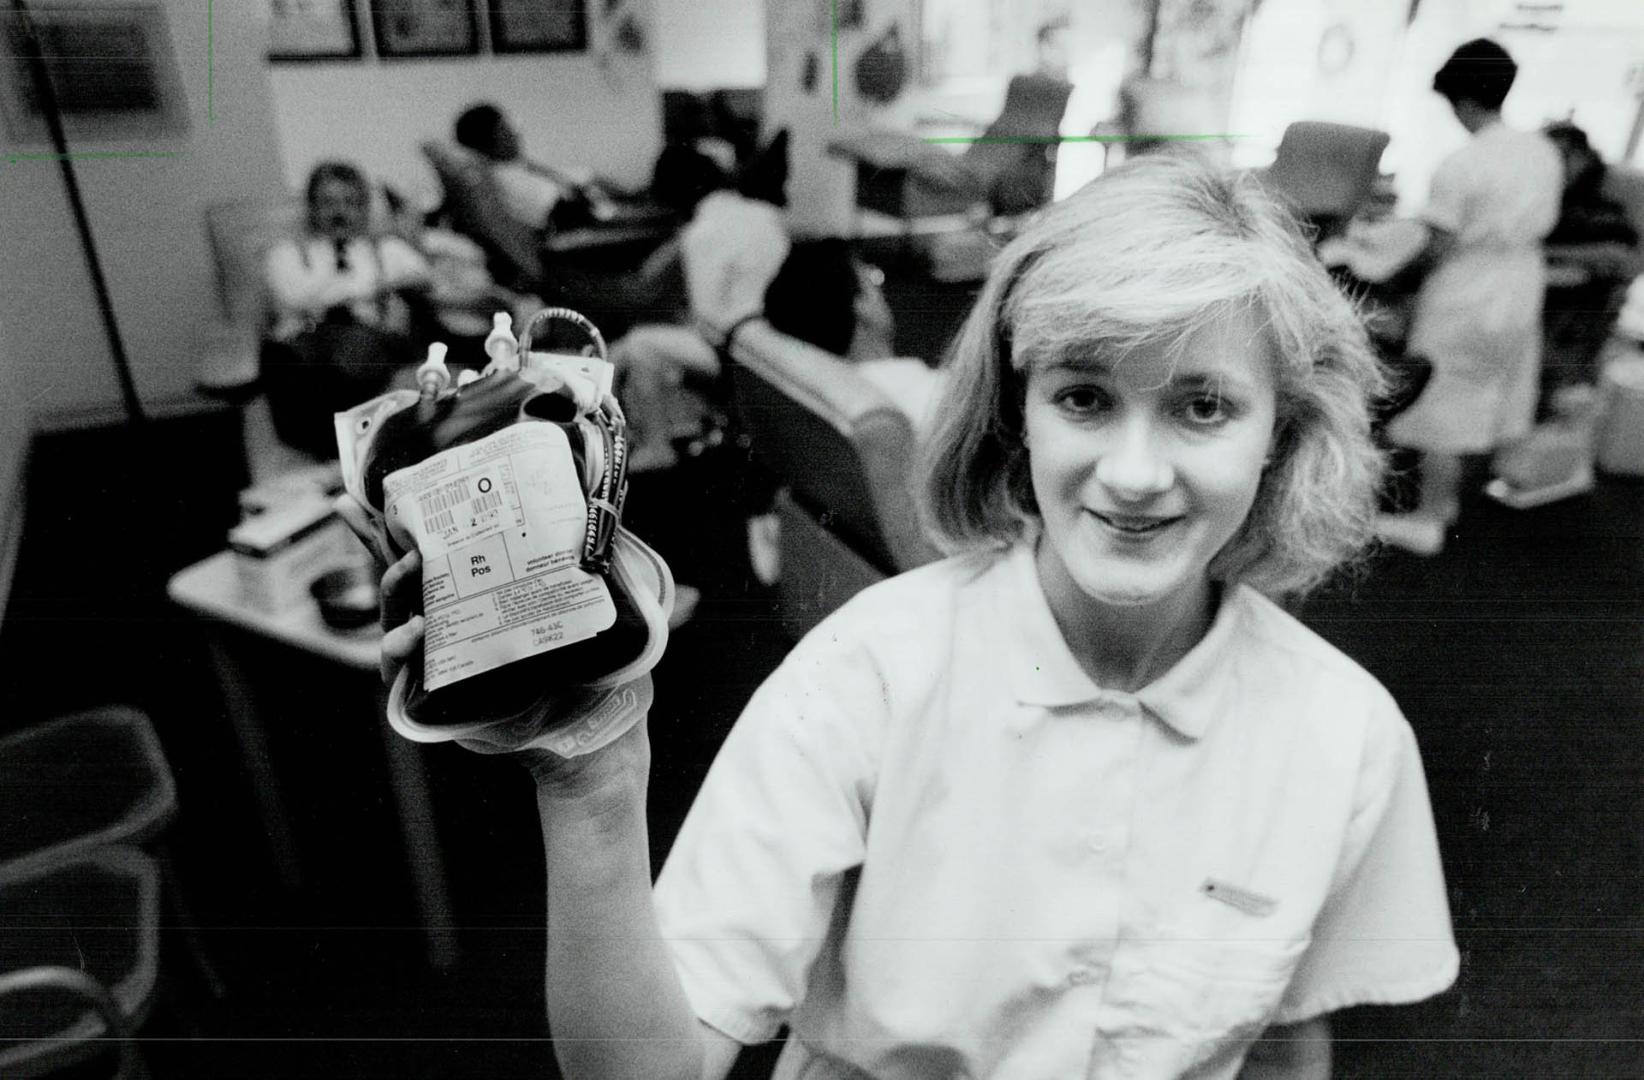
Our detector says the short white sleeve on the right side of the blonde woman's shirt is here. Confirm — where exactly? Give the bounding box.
[1274,699,1460,1024]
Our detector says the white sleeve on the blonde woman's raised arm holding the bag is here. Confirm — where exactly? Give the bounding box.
[656,625,886,1044]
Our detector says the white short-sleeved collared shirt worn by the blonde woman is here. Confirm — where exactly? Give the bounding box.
[656,546,1458,1080]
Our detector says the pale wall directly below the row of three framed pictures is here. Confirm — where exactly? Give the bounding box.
[266,0,667,205]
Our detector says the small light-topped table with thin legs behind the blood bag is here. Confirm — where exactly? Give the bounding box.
[166,551,457,968]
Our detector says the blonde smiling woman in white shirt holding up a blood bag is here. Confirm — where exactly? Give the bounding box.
[386,158,1457,1080]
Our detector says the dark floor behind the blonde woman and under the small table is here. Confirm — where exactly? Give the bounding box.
[0,259,1644,1080]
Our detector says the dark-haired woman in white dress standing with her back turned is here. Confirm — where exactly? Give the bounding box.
[1378,38,1563,554]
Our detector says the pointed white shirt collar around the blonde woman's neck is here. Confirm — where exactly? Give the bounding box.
[995,542,1249,740]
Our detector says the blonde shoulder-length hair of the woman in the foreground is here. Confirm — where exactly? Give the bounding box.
[919,155,1386,597]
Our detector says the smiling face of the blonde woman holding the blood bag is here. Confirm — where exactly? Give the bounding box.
[1023,316,1277,620]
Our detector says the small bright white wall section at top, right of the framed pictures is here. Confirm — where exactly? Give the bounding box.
[656,0,764,90]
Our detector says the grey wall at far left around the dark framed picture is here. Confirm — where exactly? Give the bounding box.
[0,0,279,426]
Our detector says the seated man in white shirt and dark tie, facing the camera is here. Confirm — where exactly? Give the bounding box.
[261,161,432,459]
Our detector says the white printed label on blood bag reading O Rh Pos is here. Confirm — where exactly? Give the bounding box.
[383,424,617,690]
